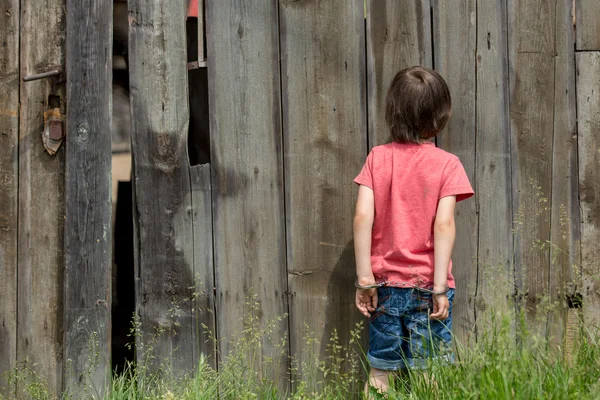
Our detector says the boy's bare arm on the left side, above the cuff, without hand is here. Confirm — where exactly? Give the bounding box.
[354,185,375,285]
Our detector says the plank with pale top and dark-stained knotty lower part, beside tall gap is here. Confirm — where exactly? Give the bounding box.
[129,0,197,373]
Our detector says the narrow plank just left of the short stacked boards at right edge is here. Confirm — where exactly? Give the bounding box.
[548,1,581,344]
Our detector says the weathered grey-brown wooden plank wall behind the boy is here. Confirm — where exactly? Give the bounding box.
[0,0,600,393]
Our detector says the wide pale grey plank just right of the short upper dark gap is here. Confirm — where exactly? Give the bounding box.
[206,0,288,388]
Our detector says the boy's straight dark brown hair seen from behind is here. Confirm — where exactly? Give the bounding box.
[385,67,452,143]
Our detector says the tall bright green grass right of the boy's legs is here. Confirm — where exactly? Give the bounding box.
[390,312,600,400]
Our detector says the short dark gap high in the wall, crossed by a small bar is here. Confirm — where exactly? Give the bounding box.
[186,17,210,165]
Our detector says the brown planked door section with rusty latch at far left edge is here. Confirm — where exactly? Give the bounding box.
[0,0,66,398]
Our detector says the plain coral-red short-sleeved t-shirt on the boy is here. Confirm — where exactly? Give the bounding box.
[354,143,473,288]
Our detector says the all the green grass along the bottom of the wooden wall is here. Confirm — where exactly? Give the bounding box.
[4,304,600,400]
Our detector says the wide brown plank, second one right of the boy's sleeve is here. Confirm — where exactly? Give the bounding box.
[508,0,555,335]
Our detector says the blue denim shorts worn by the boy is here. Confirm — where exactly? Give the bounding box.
[367,287,454,371]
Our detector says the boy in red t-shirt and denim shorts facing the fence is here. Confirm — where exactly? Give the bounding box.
[354,67,473,392]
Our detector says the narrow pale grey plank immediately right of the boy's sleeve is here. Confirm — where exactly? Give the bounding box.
[476,0,514,331]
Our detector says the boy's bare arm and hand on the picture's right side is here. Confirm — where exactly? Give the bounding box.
[431,196,456,320]
